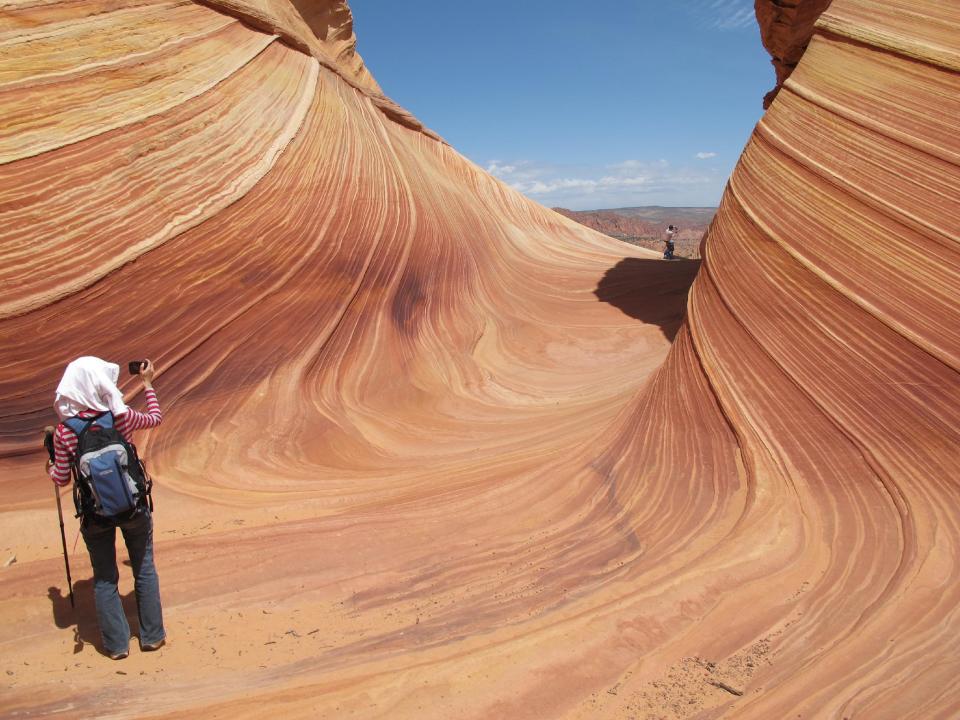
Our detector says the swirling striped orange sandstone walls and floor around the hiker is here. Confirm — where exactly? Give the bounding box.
[0,0,960,718]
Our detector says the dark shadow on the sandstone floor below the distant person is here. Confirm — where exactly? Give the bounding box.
[593,258,700,342]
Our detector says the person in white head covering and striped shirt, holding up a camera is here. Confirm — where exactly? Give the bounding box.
[48,357,166,660]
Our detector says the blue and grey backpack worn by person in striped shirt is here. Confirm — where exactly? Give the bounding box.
[63,412,153,520]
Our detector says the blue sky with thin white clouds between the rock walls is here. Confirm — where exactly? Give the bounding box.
[350,0,774,210]
